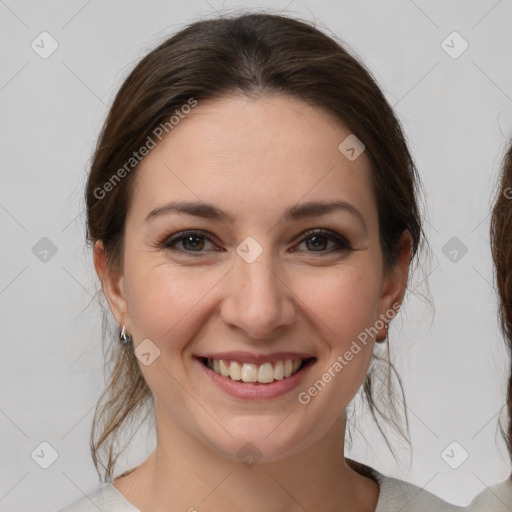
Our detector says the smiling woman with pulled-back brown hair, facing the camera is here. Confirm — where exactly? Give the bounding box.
[57,14,459,512]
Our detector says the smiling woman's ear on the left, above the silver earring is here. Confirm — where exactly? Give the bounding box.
[94,240,131,332]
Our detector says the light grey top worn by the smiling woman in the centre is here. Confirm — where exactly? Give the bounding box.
[57,465,464,512]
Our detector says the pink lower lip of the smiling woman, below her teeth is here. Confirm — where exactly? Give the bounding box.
[197,359,314,400]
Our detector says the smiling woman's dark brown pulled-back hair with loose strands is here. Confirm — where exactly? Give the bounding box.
[86,13,423,484]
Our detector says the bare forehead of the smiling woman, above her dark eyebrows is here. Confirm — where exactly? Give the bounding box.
[131,95,376,226]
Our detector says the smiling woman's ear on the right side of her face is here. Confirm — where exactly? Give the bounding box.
[375,230,412,342]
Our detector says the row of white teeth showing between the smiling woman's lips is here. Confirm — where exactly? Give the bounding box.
[199,357,316,384]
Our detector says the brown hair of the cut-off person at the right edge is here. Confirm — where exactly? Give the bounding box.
[490,140,512,464]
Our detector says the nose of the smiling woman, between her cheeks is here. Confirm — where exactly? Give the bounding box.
[220,246,296,340]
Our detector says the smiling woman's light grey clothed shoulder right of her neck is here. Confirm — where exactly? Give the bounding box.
[347,460,466,512]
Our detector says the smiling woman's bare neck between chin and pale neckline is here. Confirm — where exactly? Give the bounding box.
[115,411,379,512]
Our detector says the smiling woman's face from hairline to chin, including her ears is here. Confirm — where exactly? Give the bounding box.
[95,96,409,460]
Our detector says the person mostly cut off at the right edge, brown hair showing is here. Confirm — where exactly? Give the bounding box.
[469,145,512,512]
